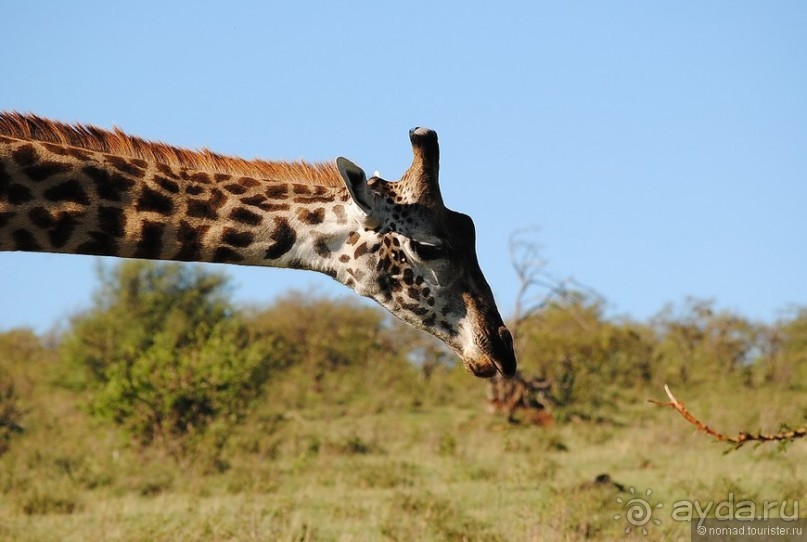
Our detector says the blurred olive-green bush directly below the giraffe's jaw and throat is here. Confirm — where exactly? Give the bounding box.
[248,291,417,410]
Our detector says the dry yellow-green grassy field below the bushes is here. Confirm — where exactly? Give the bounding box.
[0,375,807,541]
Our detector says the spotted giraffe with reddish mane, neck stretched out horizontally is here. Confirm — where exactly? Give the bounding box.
[0,112,516,378]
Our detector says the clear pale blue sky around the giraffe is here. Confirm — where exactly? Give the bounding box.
[0,0,807,331]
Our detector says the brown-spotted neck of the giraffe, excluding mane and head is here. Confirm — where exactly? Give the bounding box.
[0,135,361,283]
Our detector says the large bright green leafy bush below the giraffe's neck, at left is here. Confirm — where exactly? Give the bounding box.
[62,261,273,455]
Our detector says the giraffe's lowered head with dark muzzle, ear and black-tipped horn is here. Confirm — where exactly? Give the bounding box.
[337,128,516,377]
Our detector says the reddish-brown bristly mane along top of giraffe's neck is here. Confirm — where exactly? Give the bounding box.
[0,112,342,186]
